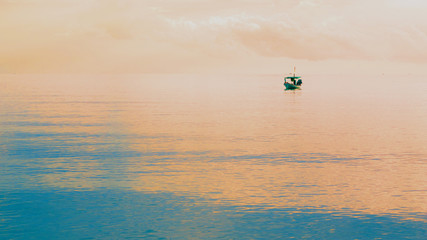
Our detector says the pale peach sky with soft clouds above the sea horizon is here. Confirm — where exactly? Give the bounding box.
[0,0,427,74]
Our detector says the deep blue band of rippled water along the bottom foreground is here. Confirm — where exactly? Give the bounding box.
[1,190,426,239]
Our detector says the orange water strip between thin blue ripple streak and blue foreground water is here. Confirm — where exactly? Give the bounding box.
[132,156,427,219]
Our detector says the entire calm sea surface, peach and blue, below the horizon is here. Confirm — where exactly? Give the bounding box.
[0,75,427,239]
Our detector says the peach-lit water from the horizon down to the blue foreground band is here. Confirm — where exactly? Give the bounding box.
[1,75,427,219]
